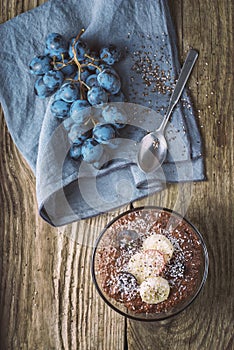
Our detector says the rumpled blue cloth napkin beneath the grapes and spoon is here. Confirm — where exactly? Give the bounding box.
[0,0,205,226]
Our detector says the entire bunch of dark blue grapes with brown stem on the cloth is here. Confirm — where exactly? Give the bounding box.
[29,30,127,168]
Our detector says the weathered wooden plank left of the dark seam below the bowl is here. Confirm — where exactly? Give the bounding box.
[0,0,125,350]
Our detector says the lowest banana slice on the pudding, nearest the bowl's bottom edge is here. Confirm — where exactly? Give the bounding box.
[140,277,170,304]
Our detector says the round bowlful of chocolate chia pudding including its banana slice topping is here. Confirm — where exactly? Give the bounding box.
[93,207,208,318]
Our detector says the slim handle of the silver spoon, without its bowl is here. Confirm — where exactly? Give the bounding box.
[159,49,198,130]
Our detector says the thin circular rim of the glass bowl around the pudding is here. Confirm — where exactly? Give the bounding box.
[91,206,209,322]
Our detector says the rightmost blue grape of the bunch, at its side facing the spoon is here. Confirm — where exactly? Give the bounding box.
[102,104,128,128]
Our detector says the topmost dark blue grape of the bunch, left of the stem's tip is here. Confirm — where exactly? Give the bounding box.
[46,33,68,57]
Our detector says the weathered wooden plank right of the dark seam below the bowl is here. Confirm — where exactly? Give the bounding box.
[131,0,234,350]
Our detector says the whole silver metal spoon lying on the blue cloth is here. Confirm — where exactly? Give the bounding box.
[137,49,198,173]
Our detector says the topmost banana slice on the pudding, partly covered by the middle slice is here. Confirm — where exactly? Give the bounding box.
[143,233,174,263]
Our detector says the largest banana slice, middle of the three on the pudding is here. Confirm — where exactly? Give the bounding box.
[128,249,165,283]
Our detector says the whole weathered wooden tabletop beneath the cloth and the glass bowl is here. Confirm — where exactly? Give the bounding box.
[0,0,234,350]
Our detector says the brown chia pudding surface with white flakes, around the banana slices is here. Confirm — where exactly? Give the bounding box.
[95,208,204,314]
